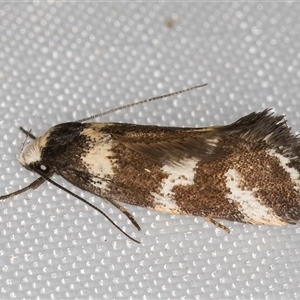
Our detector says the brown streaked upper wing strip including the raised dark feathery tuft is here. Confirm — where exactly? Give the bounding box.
[103,110,299,164]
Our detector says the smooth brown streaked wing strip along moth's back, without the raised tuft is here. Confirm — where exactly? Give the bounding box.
[104,124,220,164]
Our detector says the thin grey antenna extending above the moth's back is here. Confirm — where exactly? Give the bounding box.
[77,83,207,123]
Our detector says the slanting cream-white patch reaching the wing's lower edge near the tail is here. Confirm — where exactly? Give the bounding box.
[225,169,286,225]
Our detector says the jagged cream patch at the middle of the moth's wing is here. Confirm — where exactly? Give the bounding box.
[151,159,197,213]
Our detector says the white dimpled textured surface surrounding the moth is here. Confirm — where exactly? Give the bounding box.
[0,1,300,299]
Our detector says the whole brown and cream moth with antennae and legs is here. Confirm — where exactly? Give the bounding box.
[0,85,300,241]
